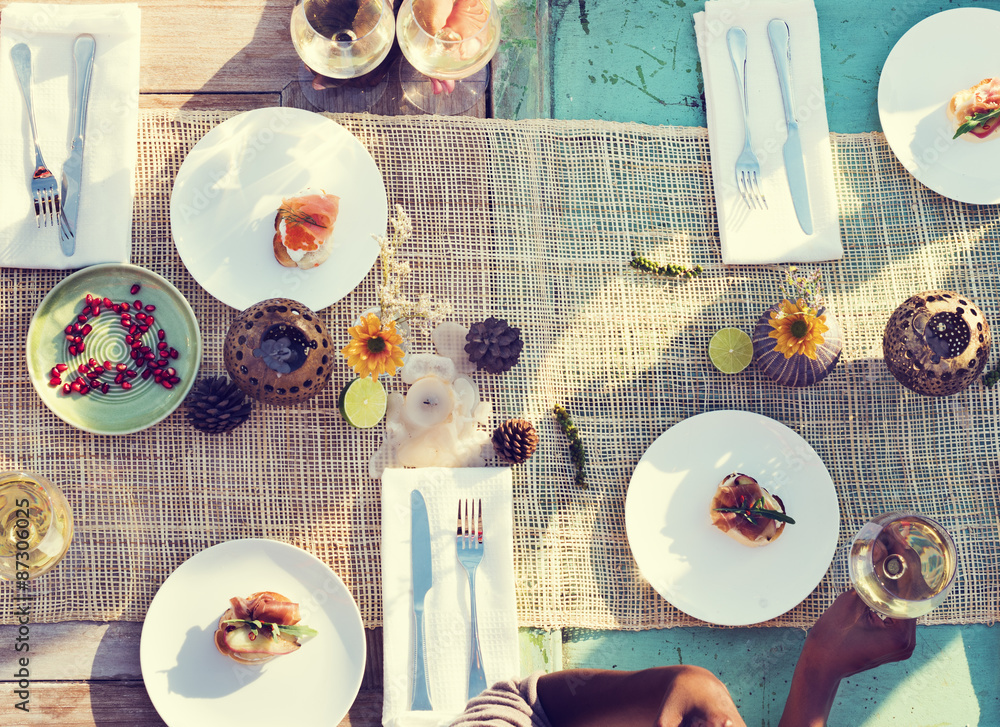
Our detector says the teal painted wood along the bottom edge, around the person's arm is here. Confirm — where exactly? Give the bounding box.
[562,625,1000,727]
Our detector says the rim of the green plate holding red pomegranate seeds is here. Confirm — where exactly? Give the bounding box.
[24,262,203,437]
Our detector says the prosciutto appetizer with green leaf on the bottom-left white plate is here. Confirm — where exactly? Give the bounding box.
[215,591,316,664]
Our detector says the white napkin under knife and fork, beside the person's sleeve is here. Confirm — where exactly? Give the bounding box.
[382,467,520,727]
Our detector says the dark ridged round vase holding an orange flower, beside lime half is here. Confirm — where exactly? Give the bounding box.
[752,303,844,387]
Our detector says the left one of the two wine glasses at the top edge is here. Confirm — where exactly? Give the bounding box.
[291,0,395,111]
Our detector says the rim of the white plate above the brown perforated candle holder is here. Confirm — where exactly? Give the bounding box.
[168,106,390,313]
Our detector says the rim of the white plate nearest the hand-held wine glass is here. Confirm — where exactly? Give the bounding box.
[624,409,841,627]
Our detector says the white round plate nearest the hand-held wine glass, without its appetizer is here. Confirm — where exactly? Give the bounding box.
[625,411,840,626]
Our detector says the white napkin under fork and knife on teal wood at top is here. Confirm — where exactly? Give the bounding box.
[694,0,844,264]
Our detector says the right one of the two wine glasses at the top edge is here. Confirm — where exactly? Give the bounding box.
[396,0,500,115]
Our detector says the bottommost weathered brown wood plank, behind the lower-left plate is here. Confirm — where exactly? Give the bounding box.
[0,681,382,727]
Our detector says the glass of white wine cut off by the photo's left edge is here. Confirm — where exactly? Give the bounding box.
[0,472,73,581]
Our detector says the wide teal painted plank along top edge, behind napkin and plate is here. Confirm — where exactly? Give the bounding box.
[552,0,1000,133]
